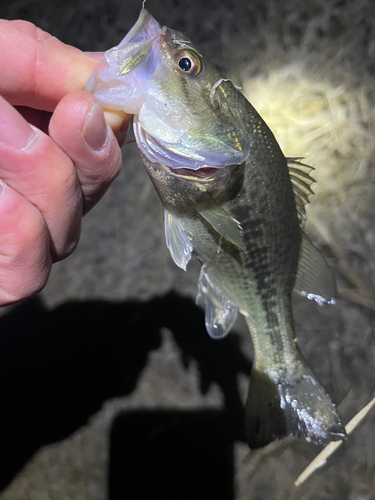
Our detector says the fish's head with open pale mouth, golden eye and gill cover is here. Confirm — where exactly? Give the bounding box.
[86,9,250,178]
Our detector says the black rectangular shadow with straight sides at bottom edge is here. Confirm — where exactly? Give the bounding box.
[108,410,234,500]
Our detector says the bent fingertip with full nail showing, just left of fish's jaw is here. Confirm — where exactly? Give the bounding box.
[49,91,128,212]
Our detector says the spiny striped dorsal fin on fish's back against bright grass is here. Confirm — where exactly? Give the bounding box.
[286,158,315,227]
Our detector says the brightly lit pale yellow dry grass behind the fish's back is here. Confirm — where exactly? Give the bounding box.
[237,54,375,309]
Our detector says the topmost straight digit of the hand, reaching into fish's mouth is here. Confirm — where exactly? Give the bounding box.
[0,20,98,111]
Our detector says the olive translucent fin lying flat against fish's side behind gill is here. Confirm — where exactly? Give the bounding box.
[195,193,245,250]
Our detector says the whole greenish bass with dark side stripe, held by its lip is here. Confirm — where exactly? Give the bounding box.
[85,8,345,449]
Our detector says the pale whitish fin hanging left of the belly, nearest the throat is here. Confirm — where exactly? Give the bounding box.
[164,210,193,271]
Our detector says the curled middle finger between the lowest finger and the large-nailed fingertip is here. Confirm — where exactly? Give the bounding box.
[0,97,82,260]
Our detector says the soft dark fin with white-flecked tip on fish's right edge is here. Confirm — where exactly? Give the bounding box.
[294,231,336,305]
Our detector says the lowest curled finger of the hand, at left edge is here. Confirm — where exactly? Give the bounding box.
[0,180,52,306]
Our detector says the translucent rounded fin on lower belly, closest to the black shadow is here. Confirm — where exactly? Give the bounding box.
[197,266,237,339]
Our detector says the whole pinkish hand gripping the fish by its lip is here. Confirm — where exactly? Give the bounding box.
[0,20,131,306]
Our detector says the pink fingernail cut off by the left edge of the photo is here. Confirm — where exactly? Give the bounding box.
[0,97,36,150]
